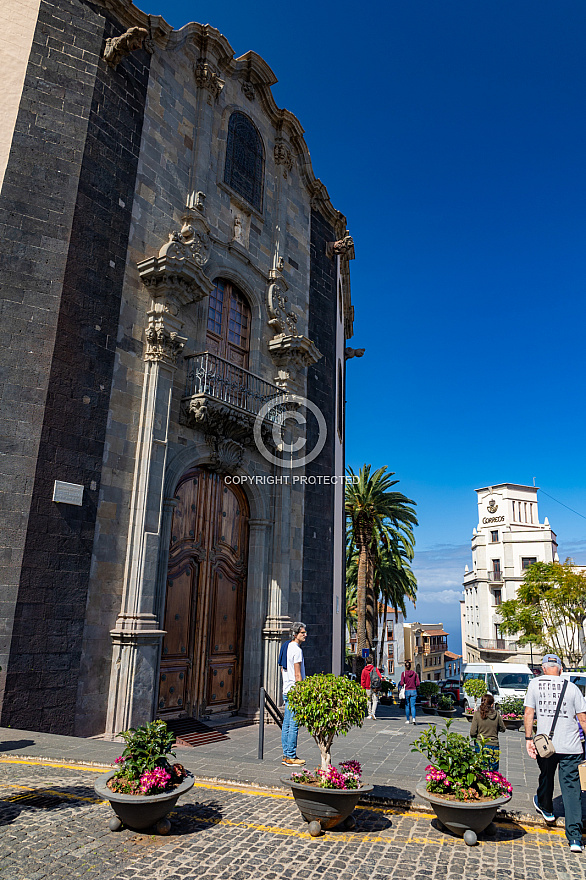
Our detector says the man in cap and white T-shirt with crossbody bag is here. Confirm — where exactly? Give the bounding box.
[524,654,586,853]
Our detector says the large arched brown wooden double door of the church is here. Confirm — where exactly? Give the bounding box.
[158,468,249,718]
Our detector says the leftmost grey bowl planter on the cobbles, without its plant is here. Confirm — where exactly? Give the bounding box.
[94,770,195,834]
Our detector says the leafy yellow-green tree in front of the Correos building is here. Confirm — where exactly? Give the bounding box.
[499,559,586,666]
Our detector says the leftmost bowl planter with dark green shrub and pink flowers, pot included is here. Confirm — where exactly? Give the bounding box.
[94,720,194,834]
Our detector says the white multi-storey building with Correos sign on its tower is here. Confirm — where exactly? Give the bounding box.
[460,483,558,663]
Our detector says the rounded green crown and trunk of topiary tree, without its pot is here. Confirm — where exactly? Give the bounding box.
[287,673,368,770]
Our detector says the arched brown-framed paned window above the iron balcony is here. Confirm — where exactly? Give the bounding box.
[207,278,250,368]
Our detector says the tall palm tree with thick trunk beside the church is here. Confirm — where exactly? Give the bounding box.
[346,464,417,654]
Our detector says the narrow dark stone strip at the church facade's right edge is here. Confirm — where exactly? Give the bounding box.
[301,211,337,675]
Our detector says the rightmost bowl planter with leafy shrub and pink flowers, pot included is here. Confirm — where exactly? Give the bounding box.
[411,719,513,846]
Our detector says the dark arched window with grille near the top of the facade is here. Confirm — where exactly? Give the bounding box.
[224,111,264,211]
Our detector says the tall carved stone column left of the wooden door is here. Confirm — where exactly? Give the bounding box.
[106,224,211,737]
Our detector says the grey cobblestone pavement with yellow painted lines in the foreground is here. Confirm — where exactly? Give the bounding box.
[0,759,586,880]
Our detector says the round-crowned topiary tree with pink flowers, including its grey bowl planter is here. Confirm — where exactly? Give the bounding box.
[281,674,374,837]
